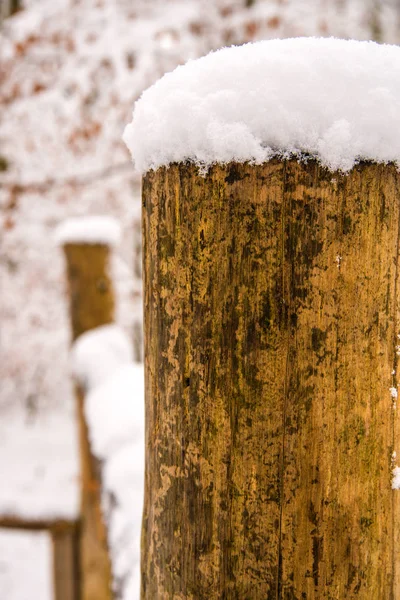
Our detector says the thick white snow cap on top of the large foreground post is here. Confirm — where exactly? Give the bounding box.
[124,38,400,173]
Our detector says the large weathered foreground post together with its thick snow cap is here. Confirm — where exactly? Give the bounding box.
[124,39,400,600]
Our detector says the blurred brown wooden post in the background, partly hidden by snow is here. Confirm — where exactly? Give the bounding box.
[64,243,115,600]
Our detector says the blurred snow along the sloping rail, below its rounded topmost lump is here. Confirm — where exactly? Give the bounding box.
[85,364,144,600]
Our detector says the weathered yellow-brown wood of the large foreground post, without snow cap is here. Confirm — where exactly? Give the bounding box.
[142,161,400,600]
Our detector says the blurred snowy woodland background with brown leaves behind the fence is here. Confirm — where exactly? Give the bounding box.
[0,0,400,600]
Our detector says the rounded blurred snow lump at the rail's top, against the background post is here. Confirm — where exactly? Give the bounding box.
[71,325,133,390]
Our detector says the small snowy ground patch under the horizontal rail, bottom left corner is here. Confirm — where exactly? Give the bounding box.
[0,529,53,600]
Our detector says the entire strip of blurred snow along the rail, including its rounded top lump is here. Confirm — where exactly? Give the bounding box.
[71,325,144,600]
